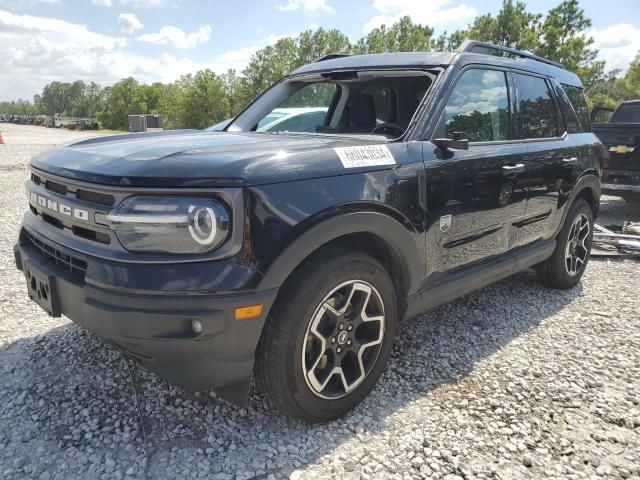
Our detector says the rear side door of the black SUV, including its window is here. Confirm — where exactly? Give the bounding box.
[511,73,580,246]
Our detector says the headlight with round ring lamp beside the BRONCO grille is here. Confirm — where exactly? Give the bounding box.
[106,197,231,253]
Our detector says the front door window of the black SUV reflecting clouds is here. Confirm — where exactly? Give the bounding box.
[444,69,509,142]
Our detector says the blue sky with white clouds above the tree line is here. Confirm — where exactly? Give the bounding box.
[0,0,640,101]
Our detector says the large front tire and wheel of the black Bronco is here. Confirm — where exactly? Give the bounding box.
[256,248,397,422]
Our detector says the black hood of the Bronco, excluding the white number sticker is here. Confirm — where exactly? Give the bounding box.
[31,130,400,187]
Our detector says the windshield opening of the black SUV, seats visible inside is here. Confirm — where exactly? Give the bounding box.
[229,70,433,138]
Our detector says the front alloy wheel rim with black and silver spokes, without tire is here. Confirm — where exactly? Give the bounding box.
[302,280,385,400]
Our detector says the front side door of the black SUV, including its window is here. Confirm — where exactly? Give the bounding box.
[424,67,526,272]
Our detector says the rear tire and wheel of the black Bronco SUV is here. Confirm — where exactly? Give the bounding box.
[536,198,593,290]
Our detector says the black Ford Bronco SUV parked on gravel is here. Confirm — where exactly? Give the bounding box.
[15,42,602,421]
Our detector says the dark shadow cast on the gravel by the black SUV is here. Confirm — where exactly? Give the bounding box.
[0,271,582,478]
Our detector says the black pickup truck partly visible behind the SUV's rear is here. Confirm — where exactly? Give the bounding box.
[592,100,640,199]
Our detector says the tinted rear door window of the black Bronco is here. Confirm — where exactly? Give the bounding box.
[516,74,558,138]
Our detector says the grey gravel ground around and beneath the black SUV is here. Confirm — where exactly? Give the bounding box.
[0,124,640,479]
